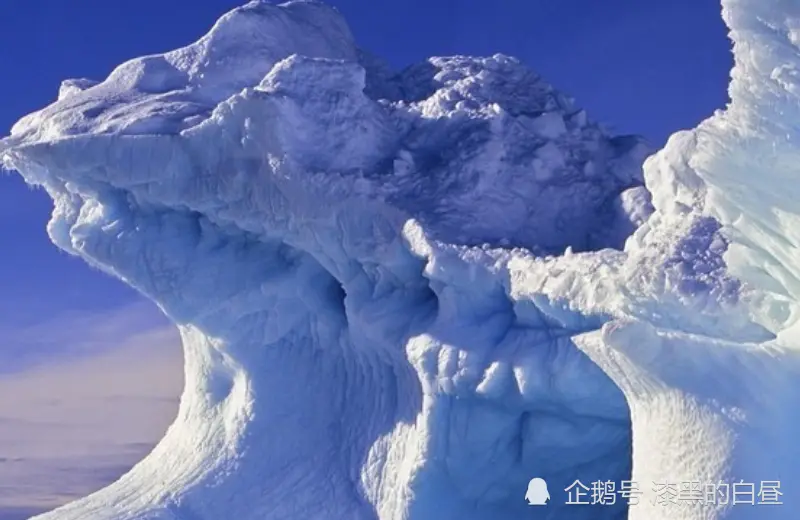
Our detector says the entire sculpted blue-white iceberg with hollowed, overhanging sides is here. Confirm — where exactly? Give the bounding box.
[0,0,800,520]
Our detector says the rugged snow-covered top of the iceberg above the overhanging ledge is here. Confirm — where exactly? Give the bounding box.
[6,2,651,253]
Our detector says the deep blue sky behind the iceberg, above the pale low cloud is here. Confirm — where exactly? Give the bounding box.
[0,0,731,516]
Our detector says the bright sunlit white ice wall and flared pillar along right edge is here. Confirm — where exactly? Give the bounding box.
[578,0,800,519]
